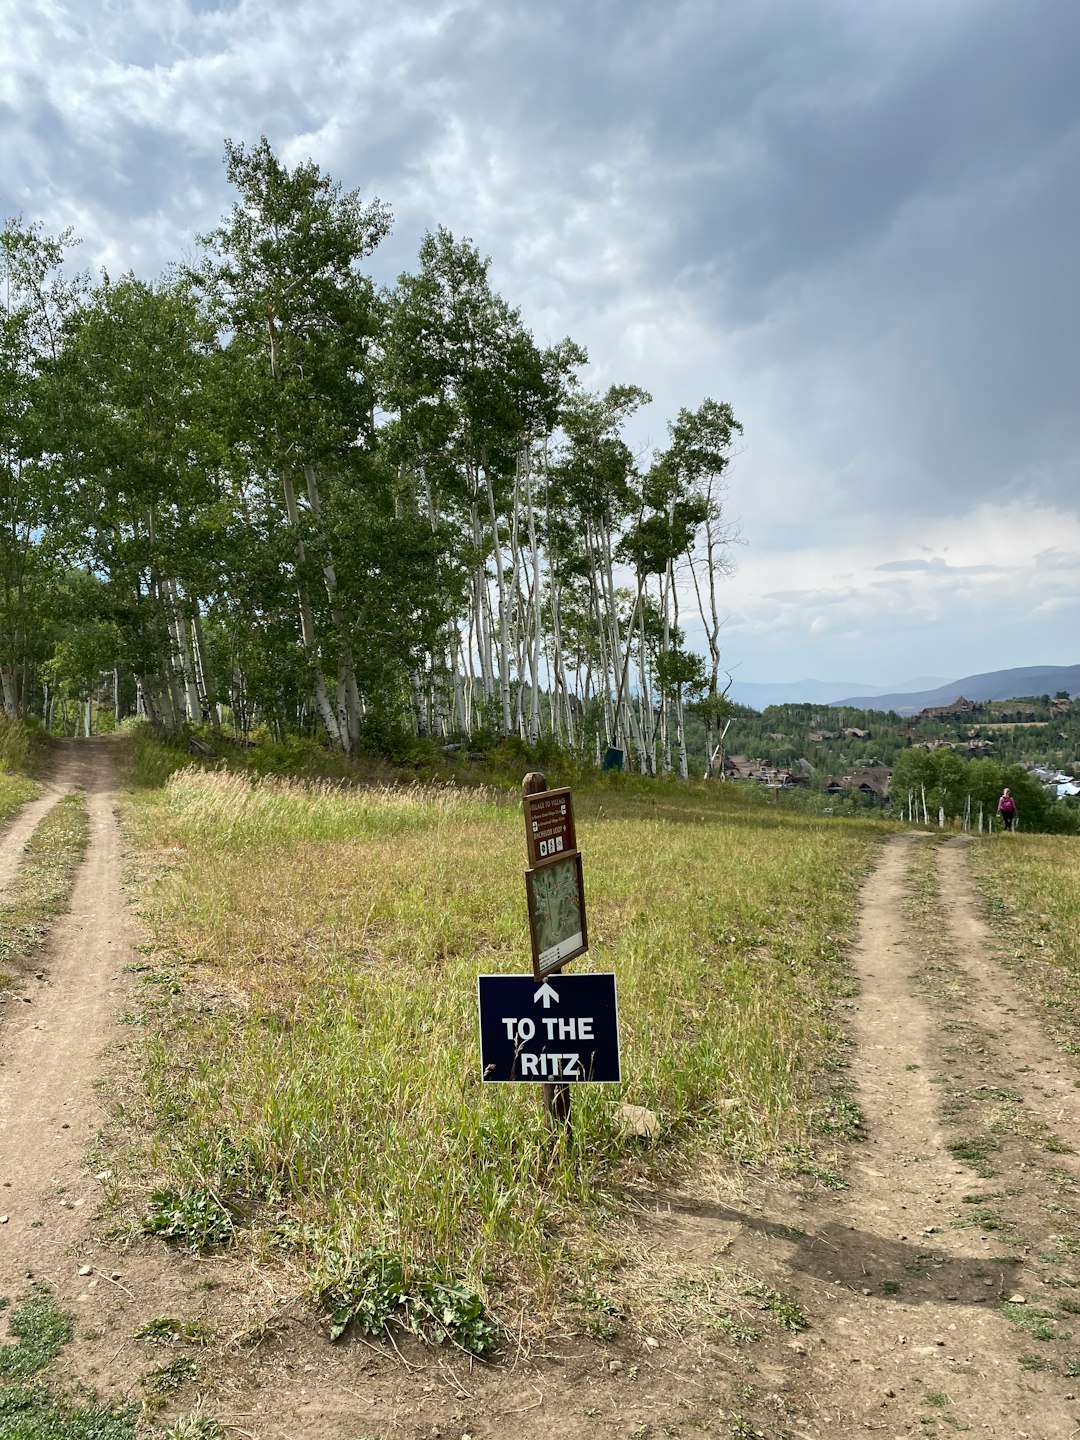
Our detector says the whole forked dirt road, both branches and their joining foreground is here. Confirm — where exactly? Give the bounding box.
[0,742,1080,1440]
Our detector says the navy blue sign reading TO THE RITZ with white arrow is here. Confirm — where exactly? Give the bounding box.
[477,975,622,1084]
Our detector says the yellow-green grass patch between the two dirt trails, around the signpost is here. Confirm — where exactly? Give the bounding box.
[125,769,881,1330]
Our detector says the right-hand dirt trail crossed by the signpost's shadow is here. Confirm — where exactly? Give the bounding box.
[668,835,1080,1440]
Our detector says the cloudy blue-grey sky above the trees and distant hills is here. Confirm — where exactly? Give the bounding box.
[0,0,1080,685]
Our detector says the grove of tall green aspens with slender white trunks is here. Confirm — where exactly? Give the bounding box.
[0,138,742,775]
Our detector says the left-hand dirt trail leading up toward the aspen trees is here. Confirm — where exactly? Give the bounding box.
[0,740,197,1395]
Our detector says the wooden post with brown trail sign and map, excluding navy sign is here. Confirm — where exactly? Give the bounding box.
[521,770,589,1130]
